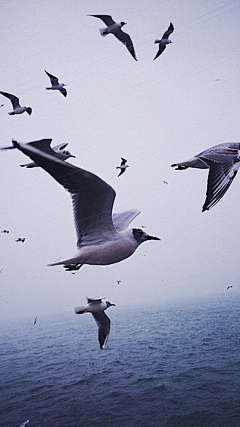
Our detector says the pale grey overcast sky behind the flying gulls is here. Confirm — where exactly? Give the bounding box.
[0,0,240,321]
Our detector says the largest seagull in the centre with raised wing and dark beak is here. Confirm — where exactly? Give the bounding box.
[4,140,160,270]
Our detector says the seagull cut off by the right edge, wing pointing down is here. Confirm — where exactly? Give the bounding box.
[171,142,240,212]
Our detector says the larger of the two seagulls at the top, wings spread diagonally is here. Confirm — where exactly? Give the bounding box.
[88,15,137,61]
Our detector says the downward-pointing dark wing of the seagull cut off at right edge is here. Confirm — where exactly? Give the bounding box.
[202,158,240,212]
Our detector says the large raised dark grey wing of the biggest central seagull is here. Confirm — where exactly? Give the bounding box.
[13,140,117,246]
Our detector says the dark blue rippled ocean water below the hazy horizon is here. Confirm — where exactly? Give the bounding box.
[0,294,240,427]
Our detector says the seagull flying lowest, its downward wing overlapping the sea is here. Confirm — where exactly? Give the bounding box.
[74,298,116,350]
